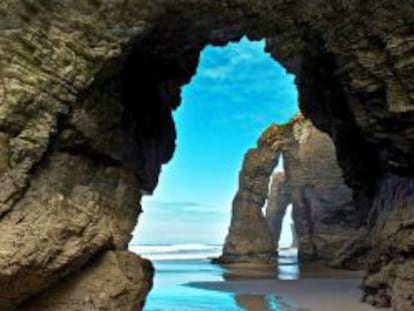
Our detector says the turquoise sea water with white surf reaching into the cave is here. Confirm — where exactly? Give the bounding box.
[130,244,298,311]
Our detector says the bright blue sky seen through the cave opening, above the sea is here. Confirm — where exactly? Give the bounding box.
[132,39,298,244]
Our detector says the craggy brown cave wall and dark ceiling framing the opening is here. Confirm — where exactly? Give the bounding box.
[0,0,414,310]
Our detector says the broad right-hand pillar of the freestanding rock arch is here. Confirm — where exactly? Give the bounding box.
[292,116,359,262]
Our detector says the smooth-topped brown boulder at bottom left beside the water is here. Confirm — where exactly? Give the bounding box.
[23,251,153,311]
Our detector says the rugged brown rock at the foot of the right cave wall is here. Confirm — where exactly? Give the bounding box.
[364,174,414,311]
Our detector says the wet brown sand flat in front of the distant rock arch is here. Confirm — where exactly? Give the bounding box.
[189,278,384,311]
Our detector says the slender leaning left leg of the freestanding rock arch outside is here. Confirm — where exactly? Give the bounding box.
[215,125,280,264]
